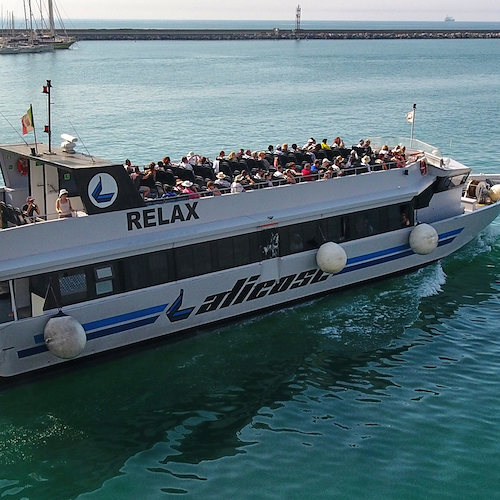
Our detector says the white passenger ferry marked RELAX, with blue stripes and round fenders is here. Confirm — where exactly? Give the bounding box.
[0,138,500,377]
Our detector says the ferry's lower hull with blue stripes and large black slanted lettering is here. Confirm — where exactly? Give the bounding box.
[0,203,500,377]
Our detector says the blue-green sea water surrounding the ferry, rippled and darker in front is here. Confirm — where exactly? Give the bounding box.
[0,31,500,500]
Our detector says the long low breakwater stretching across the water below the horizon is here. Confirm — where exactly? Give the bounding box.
[62,28,500,40]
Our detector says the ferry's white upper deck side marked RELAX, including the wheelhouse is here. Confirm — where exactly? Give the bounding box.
[0,135,470,281]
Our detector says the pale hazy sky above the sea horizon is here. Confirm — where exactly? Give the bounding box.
[0,0,500,22]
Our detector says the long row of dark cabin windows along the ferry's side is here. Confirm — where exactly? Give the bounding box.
[31,203,413,310]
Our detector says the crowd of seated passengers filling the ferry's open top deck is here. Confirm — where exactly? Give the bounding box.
[125,137,406,199]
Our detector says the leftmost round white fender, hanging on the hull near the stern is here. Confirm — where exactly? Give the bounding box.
[43,312,87,359]
